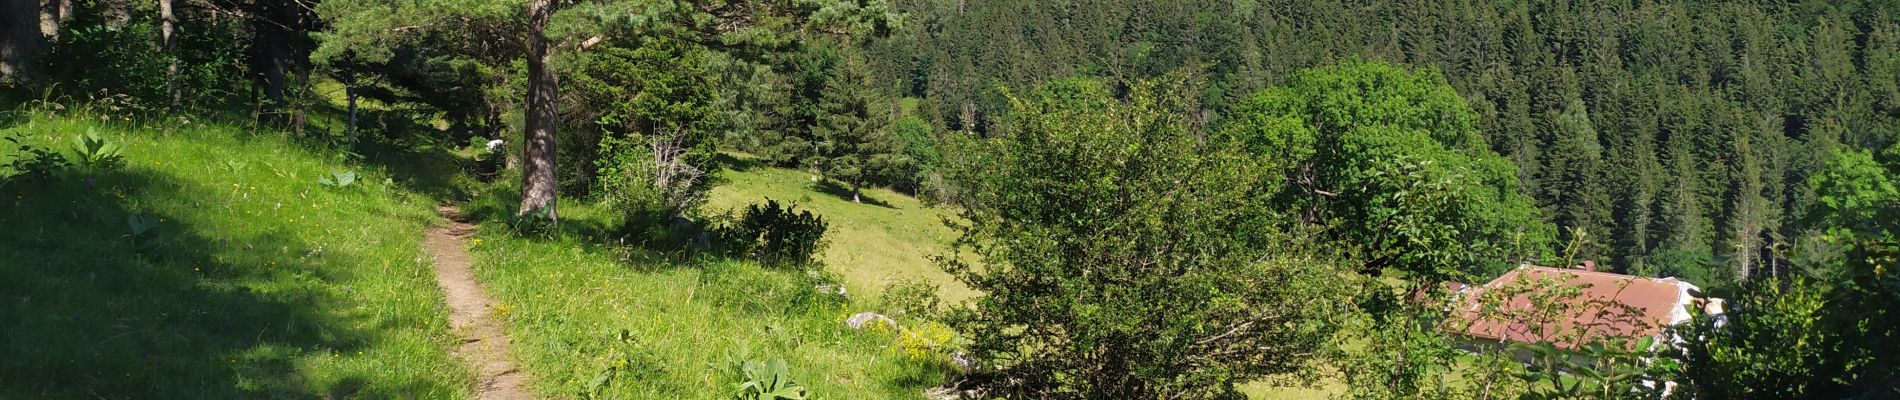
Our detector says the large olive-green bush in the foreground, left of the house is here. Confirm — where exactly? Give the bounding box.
[942,80,1340,398]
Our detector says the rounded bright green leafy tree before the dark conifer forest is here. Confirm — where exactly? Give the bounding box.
[1220,61,1550,281]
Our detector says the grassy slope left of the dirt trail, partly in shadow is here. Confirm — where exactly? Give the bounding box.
[0,118,469,398]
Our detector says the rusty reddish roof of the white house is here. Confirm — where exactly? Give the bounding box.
[1452,265,1695,349]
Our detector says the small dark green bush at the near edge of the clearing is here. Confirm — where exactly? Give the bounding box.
[720,199,828,267]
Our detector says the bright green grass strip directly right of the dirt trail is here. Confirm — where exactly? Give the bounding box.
[469,195,965,398]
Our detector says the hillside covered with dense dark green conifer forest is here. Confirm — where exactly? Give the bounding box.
[865,0,1900,281]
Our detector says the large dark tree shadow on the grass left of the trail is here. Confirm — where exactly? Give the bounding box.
[0,171,460,398]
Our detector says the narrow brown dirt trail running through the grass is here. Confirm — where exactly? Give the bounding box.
[422,205,534,400]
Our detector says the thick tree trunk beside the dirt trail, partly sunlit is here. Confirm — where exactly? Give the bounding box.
[517,0,561,222]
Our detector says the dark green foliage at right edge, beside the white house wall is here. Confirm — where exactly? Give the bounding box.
[1689,150,1900,398]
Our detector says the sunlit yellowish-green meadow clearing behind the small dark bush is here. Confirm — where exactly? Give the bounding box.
[705,155,975,301]
